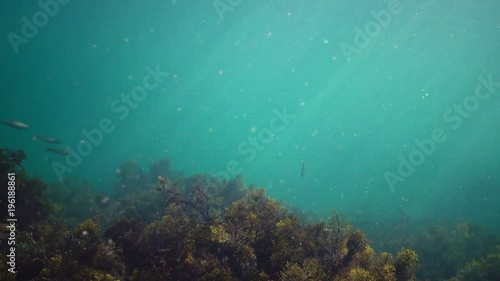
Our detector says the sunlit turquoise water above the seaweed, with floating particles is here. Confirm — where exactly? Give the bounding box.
[0,0,500,225]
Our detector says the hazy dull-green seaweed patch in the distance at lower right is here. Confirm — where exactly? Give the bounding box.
[371,218,500,280]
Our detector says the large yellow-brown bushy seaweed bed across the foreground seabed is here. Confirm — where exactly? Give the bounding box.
[0,145,500,281]
